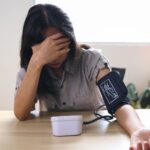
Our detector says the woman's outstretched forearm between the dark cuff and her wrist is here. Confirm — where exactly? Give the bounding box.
[115,105,144,136]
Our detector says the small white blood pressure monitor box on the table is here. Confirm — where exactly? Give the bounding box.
[51,115,83,136]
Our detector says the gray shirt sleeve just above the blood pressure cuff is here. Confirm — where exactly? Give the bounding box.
[83,50,111,82]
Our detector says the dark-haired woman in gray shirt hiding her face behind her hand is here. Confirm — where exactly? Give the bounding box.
[14,4,150,150]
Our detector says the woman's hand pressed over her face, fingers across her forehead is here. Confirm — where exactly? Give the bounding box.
[32,33,70,66]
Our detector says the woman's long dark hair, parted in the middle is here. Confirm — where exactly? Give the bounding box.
[20,4,77,94]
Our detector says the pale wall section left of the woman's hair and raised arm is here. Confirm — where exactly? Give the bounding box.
[0,0,33,110]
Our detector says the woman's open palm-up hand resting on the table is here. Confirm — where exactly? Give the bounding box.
[129,128,150,150]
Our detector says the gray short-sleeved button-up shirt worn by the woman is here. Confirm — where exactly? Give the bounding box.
[16,49,109,111]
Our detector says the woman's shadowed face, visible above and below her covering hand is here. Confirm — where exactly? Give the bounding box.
[42,27,69,69]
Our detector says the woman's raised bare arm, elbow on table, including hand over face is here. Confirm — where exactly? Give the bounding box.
[14,33,70,120]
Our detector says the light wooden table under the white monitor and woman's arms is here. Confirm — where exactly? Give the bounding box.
[0,109,150,150]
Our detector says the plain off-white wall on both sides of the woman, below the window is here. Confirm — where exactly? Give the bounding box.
[0,0,150,110]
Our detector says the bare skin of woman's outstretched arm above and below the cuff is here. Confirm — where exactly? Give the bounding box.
[96,67,150,150]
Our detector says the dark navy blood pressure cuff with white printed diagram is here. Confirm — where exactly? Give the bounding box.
[97,71,129,114]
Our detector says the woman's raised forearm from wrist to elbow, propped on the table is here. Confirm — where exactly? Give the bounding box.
[14,59,42,120]
